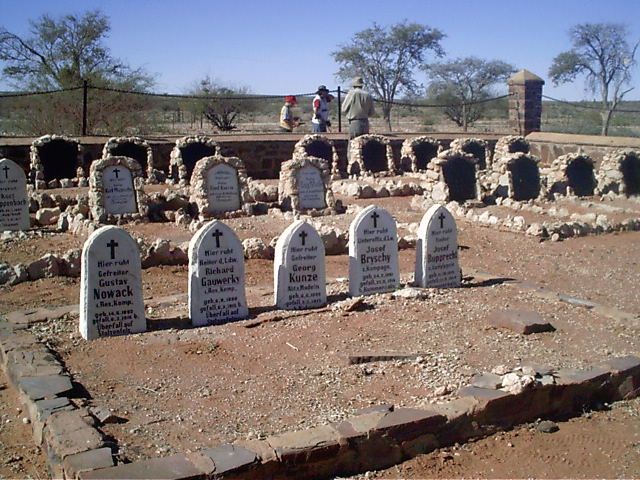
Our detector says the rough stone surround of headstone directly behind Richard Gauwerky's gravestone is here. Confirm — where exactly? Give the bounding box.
[189,155,252,218]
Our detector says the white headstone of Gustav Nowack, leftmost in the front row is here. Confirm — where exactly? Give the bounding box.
[80,226,147,340]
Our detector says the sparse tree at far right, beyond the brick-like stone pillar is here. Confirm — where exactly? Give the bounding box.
[549,23,640,135]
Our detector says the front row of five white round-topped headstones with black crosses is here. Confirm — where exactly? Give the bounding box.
[80,205,461,340]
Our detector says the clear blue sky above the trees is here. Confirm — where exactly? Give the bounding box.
[0,0,640,100]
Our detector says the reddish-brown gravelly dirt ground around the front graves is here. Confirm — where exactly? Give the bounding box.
[0,188,640,478]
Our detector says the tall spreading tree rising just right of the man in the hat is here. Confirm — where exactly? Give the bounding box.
[331,20,444,130]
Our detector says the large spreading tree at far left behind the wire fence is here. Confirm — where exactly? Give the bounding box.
[0,10,153,133]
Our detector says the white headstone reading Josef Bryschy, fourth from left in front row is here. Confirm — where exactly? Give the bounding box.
[349,205,400,297]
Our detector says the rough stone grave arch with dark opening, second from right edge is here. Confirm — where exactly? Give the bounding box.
[544,153,596,196]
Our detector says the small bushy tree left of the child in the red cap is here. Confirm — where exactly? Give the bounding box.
[193,76,255,132]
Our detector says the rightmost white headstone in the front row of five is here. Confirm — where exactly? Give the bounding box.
[415,205,461,288]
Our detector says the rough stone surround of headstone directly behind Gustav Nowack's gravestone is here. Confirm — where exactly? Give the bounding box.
[89,157,149,223]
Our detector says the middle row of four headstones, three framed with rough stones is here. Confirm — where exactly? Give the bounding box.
[0,156,334,231]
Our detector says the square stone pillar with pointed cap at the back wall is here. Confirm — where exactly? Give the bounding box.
[508,70,544,136]
